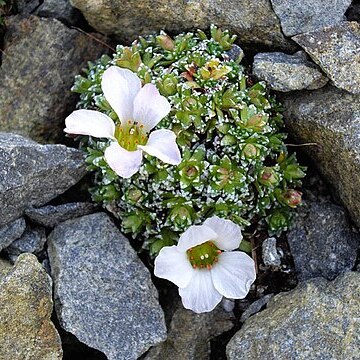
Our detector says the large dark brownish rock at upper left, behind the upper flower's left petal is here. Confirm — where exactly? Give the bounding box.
[0,16,109,143]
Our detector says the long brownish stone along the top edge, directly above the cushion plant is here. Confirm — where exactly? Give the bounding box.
[71,0,293,49]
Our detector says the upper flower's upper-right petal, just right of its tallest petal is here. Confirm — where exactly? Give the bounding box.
[133,84,171,132]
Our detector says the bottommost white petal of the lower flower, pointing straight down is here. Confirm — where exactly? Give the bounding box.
[179,270,222,314]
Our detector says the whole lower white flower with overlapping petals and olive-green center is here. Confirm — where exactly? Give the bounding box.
[155,216,256,313]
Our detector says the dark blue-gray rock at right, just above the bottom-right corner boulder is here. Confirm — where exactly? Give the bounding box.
[287,202,360,280]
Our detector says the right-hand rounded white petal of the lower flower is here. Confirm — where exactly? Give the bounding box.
[210,251,256,299]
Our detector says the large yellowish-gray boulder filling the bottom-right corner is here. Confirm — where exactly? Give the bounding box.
[227,272,360,360]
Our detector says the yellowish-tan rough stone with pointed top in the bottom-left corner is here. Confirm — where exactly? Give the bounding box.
[0,254,62,360]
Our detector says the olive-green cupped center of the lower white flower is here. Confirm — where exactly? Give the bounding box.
[186,241,221,270]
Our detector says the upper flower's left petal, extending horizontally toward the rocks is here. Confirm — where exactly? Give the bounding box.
[64,110,115,139]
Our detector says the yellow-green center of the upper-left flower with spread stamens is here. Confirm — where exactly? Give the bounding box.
[115,120,147,151]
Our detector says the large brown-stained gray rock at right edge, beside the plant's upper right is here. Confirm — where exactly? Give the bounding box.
[280,86,360,226]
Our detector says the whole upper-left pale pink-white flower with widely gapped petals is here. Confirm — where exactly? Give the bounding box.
[64,66,181,178]
